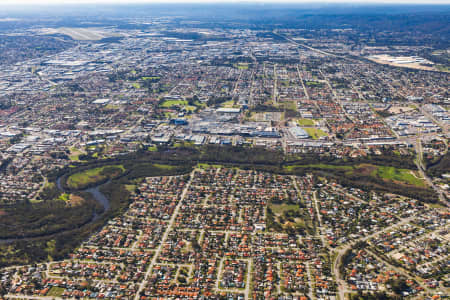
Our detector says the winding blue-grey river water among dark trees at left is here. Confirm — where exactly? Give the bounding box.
[0,176,111,244]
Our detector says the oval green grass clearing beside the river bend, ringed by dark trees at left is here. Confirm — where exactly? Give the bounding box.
[67,165,125,189]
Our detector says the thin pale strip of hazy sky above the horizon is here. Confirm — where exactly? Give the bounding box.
[0,0,450,5]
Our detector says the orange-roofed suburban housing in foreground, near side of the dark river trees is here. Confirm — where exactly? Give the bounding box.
[0,166,449,300]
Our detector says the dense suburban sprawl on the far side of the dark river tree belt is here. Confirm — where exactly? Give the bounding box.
[0,24,448,202]
